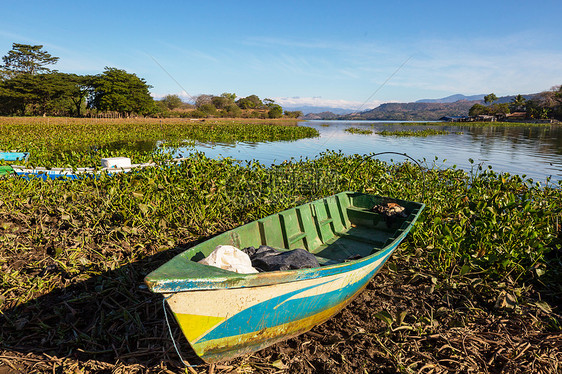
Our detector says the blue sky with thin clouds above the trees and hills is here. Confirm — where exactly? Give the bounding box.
[0,0,562,109]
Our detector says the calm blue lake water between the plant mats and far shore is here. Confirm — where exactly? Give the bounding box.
[177,121,562,181]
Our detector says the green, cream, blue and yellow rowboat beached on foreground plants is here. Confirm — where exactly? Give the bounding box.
[145,192,424,363]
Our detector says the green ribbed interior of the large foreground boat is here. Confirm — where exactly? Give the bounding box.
[186,192,423,266]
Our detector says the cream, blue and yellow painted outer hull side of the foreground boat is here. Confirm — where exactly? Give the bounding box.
[165,243,398,363]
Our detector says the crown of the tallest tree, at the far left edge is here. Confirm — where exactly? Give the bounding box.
[1,43,59,78]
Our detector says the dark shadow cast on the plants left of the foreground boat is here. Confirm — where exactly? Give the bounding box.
[0,243,204,367]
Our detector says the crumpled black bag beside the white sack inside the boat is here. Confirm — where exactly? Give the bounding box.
[242,245,320,272]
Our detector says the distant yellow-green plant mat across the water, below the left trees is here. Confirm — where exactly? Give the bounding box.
[0,117,318,167]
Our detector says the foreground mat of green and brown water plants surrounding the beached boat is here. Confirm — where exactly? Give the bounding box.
[0,119,562,374]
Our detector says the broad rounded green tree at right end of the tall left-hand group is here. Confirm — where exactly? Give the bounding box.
[88,67,154,116]
